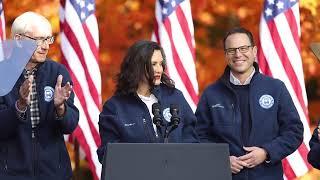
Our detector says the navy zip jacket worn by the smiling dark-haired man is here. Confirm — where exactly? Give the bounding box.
[196,63,303,180]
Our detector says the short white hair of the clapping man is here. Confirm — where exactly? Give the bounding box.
[11,11,51,37]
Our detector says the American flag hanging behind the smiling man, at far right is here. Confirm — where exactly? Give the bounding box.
[258,0,311,179]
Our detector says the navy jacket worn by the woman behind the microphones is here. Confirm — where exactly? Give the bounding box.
[97,84,199,162]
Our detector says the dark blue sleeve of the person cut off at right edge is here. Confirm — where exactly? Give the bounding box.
[308,128,320,169]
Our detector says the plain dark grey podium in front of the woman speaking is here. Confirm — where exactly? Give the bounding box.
[101,143,232,180]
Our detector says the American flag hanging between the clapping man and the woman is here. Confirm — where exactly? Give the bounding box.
[60,0,101,179]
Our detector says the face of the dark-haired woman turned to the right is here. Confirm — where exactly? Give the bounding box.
[151,50,163,85]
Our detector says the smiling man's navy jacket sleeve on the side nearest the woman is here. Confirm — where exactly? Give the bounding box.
[195,92,212,143]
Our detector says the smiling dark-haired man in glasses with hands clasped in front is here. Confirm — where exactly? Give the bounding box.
[196,28,303,180]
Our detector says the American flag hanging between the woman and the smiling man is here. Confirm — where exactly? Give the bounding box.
[152,0,198,111]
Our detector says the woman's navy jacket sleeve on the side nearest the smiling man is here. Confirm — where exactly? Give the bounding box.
[181,93,199,143]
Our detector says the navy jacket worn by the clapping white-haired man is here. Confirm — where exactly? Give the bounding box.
[0,60,79,180]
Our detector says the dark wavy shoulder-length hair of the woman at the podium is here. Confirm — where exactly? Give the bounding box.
[115,40,174,95]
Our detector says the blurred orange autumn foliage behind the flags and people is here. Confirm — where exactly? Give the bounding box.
[3,0,320,179]
